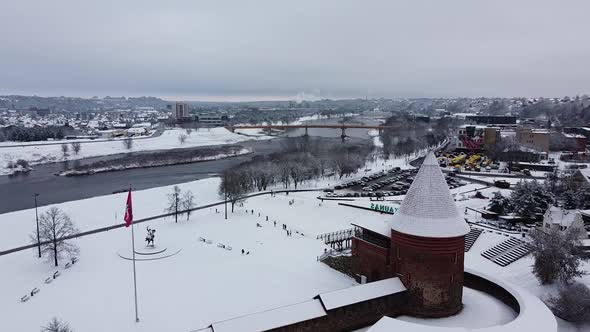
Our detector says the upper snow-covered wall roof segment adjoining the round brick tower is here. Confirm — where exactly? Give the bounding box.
[318,277,406,310]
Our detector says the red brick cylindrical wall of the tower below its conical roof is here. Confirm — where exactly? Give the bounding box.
[390,231,465,317]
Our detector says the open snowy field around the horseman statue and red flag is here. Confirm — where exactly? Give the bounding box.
[0,185,366,331]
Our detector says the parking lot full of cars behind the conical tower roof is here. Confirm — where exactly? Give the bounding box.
[326,167,465,197]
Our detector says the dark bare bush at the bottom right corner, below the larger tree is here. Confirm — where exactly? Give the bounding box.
[545,283,590,323]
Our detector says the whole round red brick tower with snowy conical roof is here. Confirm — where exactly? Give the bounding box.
[390,152,469,318]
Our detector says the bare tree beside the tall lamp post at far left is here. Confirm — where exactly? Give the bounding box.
[30,207,79,266]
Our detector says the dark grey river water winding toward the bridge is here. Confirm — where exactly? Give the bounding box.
[0,119,380,213]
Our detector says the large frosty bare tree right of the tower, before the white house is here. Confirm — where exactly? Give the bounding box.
[529,227,585,284]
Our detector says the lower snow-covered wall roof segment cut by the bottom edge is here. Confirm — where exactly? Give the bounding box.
[211,300,326,332]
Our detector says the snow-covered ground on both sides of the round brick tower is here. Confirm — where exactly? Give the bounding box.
[0,156,590,332]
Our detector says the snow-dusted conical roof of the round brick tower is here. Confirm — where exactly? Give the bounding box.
[391,151,469,238]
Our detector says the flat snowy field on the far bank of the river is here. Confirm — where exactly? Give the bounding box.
[0,127,270,175]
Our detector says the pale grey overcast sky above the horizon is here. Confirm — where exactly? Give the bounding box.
[0,0,590,100]
